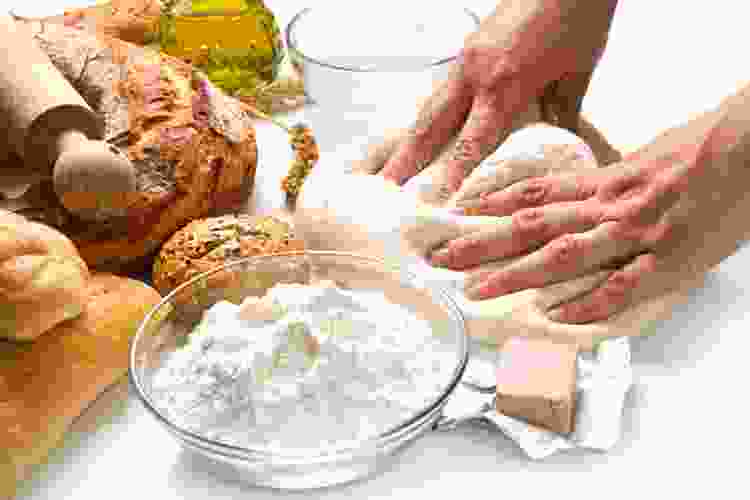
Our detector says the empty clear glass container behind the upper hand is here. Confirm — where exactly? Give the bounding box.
[286,0,479,164]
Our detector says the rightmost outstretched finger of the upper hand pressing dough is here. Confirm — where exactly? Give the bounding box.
[446,92,513,192]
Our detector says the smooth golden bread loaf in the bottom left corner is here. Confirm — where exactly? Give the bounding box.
[0,273,160,498]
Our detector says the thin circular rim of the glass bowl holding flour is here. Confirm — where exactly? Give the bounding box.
[128,250,470,464]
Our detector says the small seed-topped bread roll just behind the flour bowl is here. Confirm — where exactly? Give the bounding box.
[152,214,304,295]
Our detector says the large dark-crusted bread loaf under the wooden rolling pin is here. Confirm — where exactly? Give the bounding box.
[5,22,257,274]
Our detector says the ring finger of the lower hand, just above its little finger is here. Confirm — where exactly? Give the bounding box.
[466,222,642,300]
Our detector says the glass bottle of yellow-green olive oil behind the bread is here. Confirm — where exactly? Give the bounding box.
[158,0,283,95]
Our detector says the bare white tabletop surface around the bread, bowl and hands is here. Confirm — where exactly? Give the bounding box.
[14,0,750,500]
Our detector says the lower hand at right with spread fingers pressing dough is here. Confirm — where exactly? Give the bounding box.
[431,143,744,323]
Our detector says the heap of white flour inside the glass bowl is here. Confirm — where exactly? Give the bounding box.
[152,282,458,450]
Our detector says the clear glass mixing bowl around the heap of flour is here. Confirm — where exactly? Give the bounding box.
[129,251,469,489]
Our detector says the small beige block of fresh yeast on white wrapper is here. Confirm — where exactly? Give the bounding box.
[496,337,578,434]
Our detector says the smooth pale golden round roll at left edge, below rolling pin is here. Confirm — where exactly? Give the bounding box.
[0,210,89,340]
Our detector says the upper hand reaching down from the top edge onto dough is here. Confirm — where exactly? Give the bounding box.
[373,0,617,199]
